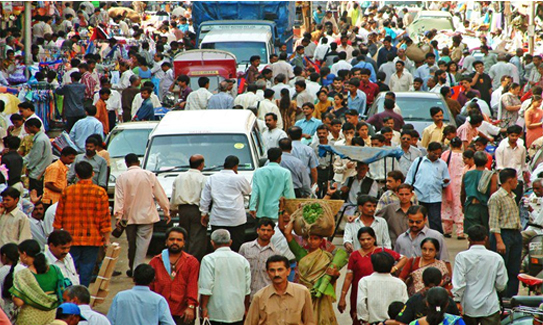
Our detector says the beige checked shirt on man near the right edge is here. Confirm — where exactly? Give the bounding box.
[488,187,522,234]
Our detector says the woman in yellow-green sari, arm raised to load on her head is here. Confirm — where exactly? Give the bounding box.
[279,209,339,325]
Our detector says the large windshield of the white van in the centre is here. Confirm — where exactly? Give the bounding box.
[145,134,254,172]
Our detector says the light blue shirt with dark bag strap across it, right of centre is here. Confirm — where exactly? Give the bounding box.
[405,156,451,203]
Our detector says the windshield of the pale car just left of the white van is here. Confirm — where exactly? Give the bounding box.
[107,128,153,158]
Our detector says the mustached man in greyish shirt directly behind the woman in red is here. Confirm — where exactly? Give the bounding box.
[394,205,450,264]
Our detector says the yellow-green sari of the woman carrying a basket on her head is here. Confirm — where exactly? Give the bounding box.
[288,240,338,325]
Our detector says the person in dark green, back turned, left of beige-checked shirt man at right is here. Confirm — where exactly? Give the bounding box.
[460,151,498,230]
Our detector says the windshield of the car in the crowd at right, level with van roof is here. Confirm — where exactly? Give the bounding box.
[377,96,450,122]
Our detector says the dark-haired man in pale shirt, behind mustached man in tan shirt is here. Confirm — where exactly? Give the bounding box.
[239,218,279,298]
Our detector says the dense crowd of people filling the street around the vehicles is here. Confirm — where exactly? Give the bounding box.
[0,1,543,325]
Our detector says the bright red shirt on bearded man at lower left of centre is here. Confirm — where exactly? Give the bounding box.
[149,252,200,316]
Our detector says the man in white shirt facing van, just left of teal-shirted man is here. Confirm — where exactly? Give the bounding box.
[200,156,251,252]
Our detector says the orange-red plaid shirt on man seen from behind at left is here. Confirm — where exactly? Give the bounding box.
[53,179,111,246]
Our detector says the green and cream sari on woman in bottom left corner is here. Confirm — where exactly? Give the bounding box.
[10,265,63,325]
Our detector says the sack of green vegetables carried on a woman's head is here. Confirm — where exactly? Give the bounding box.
[291,201,335,238]
